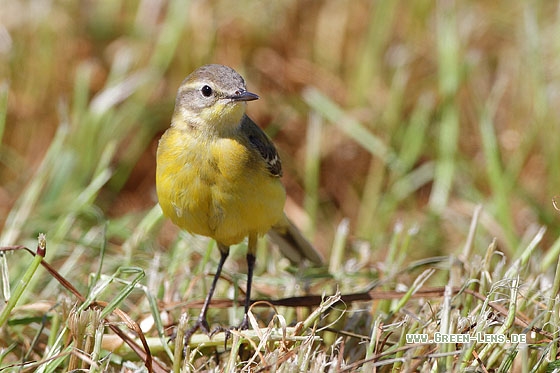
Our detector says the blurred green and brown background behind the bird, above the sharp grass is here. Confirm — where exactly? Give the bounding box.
[0,0,560,282]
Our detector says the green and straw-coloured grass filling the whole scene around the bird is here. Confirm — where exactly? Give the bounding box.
[0,0,560,372]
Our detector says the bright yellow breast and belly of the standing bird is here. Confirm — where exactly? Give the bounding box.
[156,128,286,246]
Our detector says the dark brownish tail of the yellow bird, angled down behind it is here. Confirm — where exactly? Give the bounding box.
[268,215,324,264]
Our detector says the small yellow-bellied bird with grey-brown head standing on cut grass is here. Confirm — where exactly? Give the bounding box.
[156,65,322,340]
